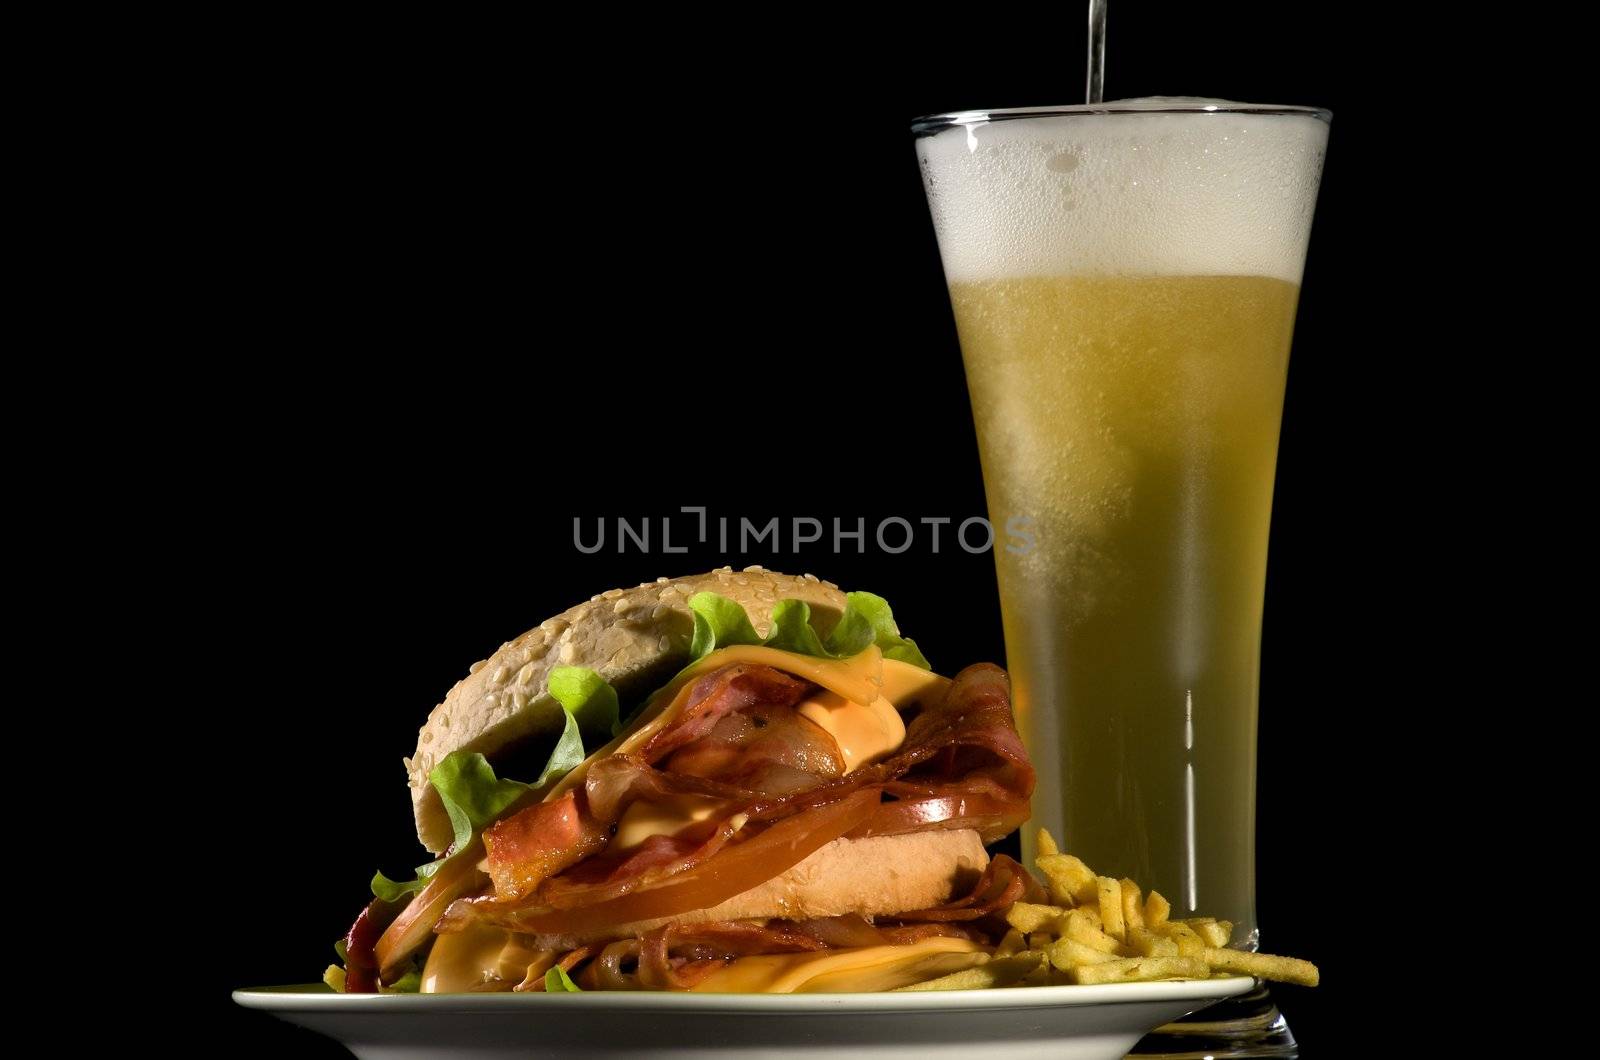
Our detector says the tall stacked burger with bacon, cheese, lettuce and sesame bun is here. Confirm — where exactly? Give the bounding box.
[325,567,1042,993]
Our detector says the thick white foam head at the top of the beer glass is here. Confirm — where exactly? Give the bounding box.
[917,98,1328,283]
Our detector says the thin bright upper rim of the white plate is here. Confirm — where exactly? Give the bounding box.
[232,975,1256,1015]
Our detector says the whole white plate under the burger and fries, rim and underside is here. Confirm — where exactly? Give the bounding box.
[234,977,1254,1060]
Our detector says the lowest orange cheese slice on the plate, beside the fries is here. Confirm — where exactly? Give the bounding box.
[691,938,989,994]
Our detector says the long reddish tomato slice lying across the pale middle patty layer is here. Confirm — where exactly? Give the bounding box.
[499,788,878,935]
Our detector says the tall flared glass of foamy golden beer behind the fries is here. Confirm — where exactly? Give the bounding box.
[914,98,1330,948]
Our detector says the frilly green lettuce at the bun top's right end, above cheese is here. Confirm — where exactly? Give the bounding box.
[690,592,933,669]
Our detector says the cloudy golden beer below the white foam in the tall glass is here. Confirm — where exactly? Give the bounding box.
[950,275,1299,941]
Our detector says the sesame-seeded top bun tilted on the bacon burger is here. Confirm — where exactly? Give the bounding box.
[405,567,845,853]
